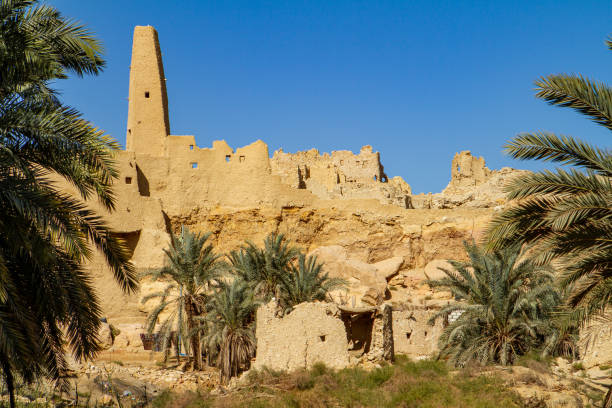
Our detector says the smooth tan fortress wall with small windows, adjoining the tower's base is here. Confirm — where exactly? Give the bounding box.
[137,136,316,217]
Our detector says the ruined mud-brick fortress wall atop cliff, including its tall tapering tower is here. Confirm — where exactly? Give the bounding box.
[120,26,410,217]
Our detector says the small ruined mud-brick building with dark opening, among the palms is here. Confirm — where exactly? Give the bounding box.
[253,301,394,371]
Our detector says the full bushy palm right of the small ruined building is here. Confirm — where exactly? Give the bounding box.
[428,242,561,366]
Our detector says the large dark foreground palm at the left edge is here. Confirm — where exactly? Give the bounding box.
[0,0,137,406]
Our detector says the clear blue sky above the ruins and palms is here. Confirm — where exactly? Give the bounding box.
[48,0,612,192]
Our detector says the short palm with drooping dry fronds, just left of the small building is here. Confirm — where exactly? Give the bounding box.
[205,279,259,380]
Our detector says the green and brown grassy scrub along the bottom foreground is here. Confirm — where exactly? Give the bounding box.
[152,357,525,408]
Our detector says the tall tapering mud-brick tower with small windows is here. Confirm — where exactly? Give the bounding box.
[126,26,170,156]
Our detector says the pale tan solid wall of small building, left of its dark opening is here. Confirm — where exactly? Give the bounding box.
[253,302,349,371]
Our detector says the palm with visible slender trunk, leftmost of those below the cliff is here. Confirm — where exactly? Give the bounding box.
[142,228,220,370]
